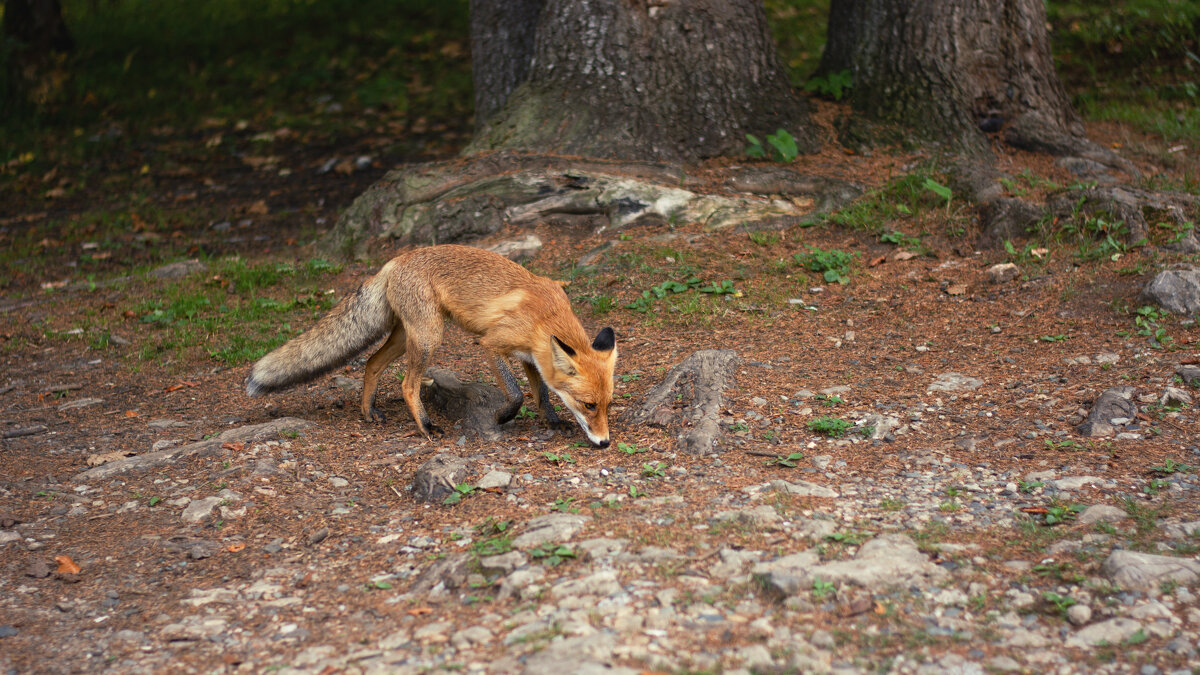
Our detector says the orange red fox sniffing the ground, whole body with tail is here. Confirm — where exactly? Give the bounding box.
[246,245,617,448]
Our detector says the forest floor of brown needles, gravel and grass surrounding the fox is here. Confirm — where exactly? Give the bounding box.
[0,94,1200,673]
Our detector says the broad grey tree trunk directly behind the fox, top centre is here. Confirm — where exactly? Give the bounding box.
[468,0,815,161]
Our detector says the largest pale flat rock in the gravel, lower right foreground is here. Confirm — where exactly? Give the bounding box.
[754,534,946,596]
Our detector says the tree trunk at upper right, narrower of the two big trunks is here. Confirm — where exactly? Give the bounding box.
[818,0,1091,154]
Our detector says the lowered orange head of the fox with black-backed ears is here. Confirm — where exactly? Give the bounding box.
[541,328,617,448]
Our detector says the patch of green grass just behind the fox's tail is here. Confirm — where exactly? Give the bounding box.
[132,259,338,365]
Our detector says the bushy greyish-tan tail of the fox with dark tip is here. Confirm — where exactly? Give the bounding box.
[246,265,396,396]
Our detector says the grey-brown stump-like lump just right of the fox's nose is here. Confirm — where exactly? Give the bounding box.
[623,350,742,454]
